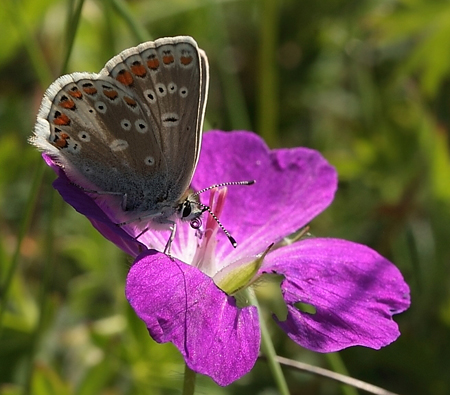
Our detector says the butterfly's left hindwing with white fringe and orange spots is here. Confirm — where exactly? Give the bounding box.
[31,73,169,211]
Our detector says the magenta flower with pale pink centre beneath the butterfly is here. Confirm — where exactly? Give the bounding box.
[46,131,409,385]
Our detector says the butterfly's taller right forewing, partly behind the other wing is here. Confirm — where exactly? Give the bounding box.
[100,36,209,202]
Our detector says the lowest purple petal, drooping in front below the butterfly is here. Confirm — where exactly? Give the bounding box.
[126,250,260,385]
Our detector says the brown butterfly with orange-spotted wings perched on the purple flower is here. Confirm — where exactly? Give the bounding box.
[30,36,209,253]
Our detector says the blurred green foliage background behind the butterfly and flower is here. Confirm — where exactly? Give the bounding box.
[0,0,450,395]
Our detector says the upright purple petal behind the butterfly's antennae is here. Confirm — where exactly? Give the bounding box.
[192,131,337,262]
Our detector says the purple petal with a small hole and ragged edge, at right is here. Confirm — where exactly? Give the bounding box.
[261,238,410,352]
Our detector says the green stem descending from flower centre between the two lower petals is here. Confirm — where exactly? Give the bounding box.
[246,290,290,395]
